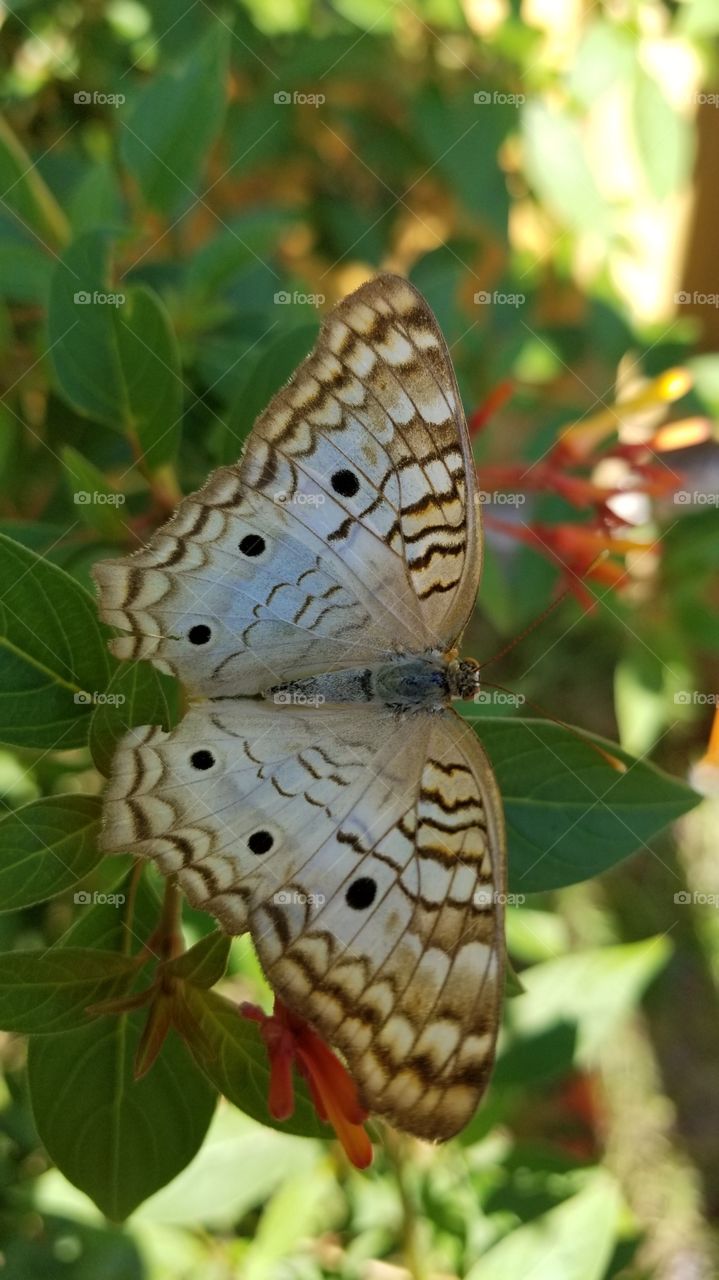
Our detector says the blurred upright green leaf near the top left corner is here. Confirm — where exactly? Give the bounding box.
[120,19,230,214]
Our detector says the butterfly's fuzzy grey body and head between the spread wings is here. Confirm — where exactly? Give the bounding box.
[265,652,480,710]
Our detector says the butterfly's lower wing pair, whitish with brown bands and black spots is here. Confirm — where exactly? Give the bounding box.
[104,700,504,1138]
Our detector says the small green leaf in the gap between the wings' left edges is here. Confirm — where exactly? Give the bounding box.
[90,662,179,777]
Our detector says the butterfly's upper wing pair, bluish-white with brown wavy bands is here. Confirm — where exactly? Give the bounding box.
[95,276,480,696]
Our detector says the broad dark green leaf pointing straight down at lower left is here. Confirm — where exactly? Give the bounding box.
[28,1010,216,1221]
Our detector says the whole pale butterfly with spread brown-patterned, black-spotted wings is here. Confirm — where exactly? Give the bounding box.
[95,274,505,1140]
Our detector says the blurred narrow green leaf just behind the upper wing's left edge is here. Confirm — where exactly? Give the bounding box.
[219,325,317,465]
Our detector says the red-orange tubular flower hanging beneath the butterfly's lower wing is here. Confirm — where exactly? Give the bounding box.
[239,996,372,1169]
